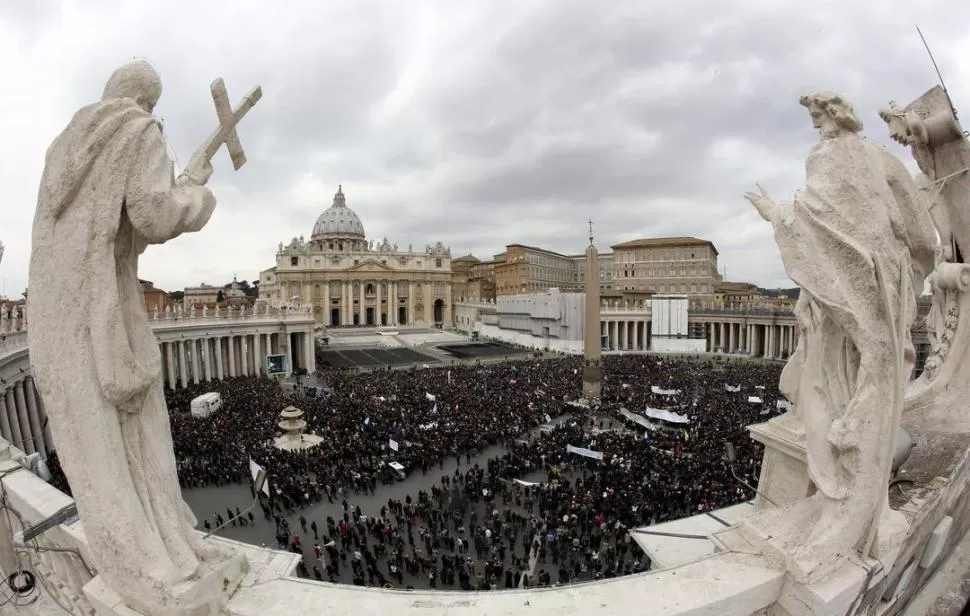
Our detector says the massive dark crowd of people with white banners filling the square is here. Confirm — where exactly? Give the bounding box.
[52,348,781,589]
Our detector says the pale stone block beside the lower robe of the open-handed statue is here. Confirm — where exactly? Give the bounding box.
[748,411,811,511]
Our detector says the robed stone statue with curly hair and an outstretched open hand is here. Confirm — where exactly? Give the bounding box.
[745,92,936,582]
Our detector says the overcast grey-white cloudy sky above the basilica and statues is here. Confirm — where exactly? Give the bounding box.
[0,0,970,298]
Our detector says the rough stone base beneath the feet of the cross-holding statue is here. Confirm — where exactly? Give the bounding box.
[84,554,250,616]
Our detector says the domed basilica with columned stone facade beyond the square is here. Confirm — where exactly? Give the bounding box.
[259,187,452,327]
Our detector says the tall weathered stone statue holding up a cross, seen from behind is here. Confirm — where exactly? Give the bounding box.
[28,61,260,615]
